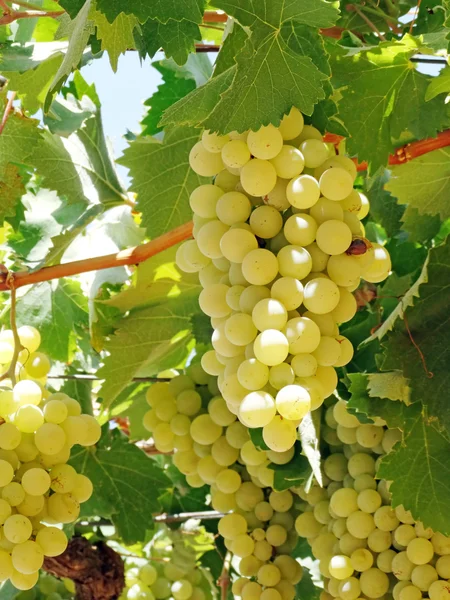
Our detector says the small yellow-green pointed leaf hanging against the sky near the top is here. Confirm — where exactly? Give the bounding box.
[92,10,139,72]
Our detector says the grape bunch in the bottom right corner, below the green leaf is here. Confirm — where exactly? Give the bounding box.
[295,400,450,600]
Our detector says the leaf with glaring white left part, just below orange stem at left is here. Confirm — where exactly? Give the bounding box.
[12,278,89,362]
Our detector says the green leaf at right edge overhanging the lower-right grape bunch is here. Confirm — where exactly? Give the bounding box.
[377,404,450,535]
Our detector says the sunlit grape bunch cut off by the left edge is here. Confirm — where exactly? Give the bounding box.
[0,326,101,590]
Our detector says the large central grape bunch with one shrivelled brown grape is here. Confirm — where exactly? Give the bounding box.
[177,108,391,452]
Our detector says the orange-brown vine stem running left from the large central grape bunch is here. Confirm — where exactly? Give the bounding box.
[0,221,193,290]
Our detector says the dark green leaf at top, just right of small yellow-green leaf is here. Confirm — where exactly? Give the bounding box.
[136,19,202,65]
